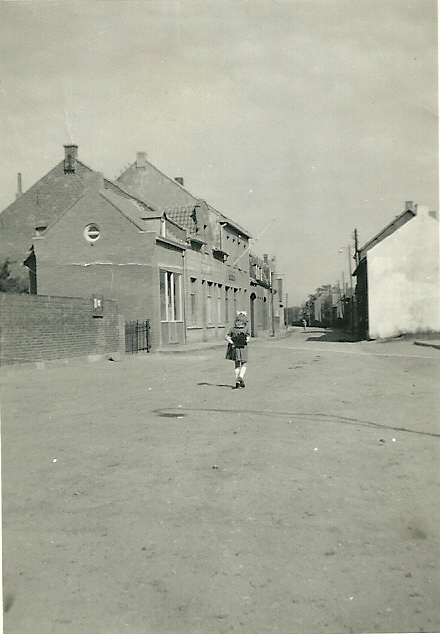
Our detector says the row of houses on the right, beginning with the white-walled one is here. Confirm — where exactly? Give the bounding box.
[302,201,440,339]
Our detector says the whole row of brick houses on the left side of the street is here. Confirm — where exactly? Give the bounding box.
[0,144,284,348]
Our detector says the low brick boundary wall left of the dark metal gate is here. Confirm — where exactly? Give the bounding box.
[0,293,125,365]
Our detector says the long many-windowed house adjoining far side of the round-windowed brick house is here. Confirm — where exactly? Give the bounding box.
[117,152,251,343]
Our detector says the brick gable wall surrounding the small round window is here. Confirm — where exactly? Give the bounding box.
[34,192,160,321]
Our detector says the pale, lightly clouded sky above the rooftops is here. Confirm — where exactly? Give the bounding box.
[0,0,438,304]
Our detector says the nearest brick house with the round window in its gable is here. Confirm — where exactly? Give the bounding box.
[33,172,187,347]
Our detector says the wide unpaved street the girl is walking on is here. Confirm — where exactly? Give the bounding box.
[1,329,440,634]
